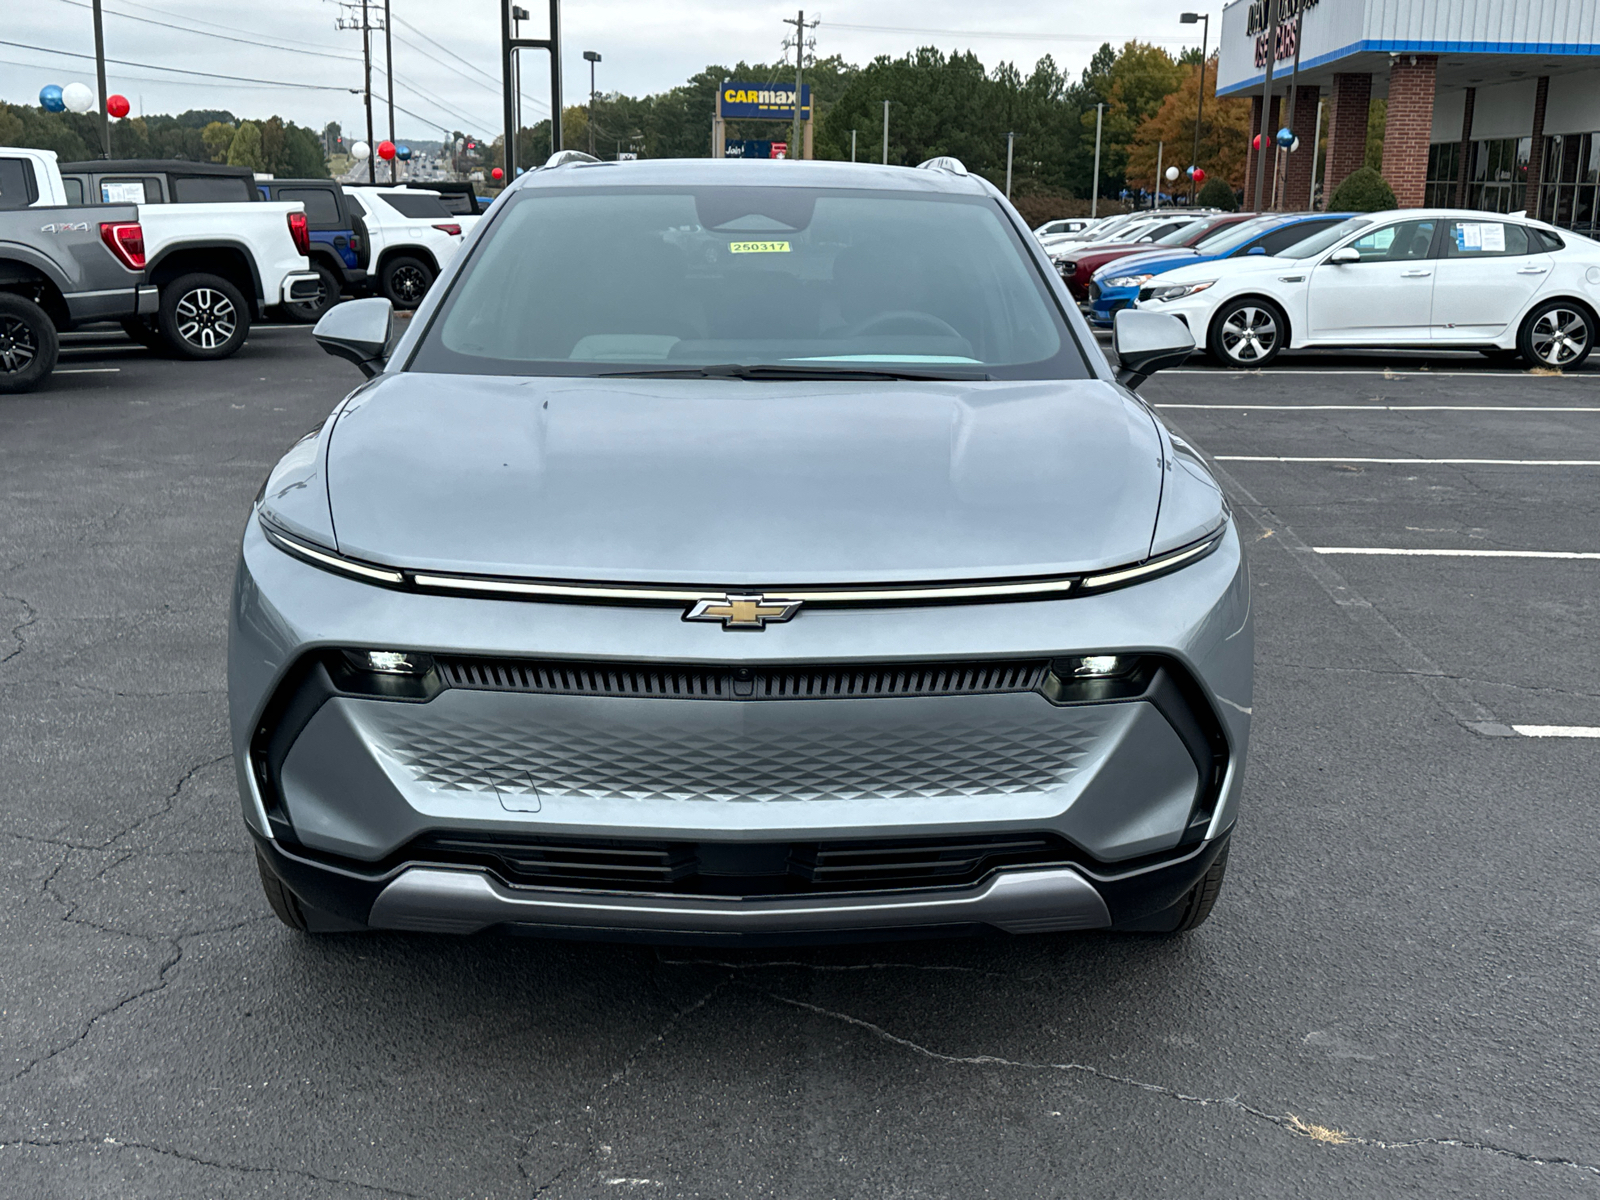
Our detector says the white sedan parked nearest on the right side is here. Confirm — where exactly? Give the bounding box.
[1136,208,1600,370]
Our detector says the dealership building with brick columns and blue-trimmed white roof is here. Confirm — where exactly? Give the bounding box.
[1218,0,1600,234]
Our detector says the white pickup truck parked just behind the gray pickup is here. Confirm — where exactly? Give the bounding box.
[0,147,322,358]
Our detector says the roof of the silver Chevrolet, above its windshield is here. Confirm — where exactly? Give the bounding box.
[506,158,990,195]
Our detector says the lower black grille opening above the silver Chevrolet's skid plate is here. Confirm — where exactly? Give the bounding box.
[402,834,1072,896]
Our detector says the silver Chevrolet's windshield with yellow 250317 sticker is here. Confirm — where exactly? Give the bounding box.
[411,186,1088,379]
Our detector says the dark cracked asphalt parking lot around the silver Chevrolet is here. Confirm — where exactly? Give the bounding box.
[0,326,1600,1200]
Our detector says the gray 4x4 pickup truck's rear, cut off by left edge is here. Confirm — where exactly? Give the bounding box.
[0,190,160,394]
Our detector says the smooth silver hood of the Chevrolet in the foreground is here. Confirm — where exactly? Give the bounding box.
[326,373,1162,586]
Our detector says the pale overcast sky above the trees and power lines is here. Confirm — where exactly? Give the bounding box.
[0,0,1203,141]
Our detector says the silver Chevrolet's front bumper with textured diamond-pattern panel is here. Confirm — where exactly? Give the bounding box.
[229,522,1251,936]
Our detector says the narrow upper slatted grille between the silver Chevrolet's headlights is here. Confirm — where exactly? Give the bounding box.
[438,658,1050,701]
